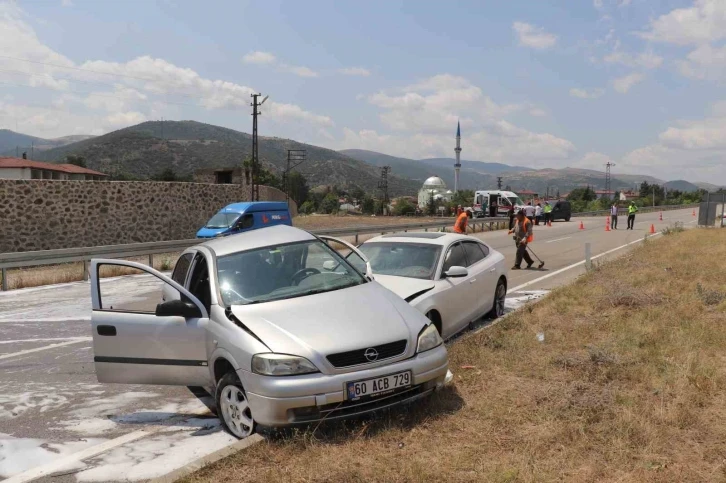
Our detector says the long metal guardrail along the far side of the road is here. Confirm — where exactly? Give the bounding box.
[0,217,509,290]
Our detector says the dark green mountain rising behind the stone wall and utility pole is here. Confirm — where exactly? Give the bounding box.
[29,121,420,196]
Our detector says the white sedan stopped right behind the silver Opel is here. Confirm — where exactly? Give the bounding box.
[351,232,507,339]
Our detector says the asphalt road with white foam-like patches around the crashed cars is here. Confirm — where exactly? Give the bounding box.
[0,210,696,482]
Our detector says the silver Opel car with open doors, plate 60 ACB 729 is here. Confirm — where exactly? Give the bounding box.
[91,226,448,438]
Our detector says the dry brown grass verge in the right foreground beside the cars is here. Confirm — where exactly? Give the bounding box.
[187,230,726,482]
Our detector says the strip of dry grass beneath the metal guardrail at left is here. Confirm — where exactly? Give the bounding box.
[8,253,179,290]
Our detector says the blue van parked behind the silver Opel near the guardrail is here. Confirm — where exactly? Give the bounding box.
[197,201,292,238]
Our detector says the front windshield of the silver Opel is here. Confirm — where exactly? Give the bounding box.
[217,240,365,306]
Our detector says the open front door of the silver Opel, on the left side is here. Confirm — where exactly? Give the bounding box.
[91,260,212,386]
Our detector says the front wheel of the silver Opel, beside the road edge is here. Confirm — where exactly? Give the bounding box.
[214,372,257,439]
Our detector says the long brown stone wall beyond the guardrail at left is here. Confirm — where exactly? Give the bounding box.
[0,179,297,253]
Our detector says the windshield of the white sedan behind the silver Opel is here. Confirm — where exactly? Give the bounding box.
[359,242,441,279]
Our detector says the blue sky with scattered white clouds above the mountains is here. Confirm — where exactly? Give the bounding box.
[0,0,726,184]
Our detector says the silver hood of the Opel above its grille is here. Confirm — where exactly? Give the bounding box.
[231,282,428,359]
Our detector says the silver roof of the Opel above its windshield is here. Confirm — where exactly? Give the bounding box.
[197,225,316,257]
